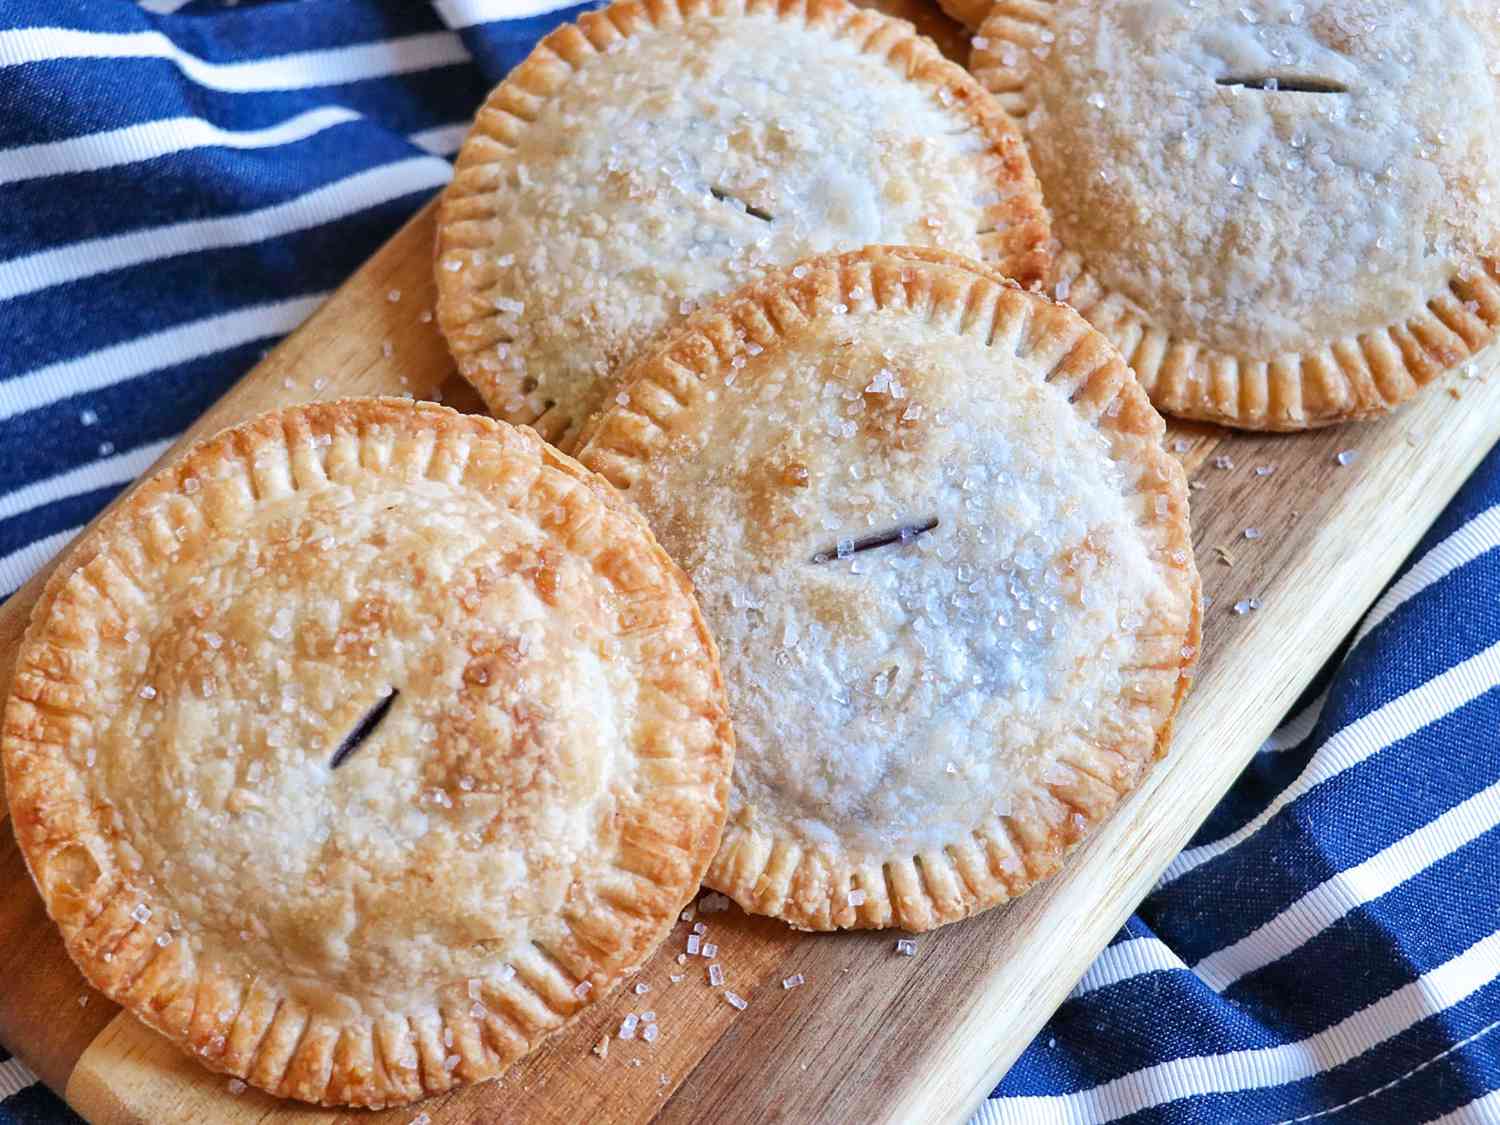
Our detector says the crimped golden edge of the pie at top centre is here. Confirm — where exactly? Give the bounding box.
[434,0,1052,450]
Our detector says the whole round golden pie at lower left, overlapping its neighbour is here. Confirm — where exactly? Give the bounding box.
[5,399,732,1106]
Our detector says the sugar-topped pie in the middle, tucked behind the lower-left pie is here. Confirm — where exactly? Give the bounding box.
[567,248,1199,930]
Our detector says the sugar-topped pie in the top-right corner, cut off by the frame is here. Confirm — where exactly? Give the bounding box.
[972,0,1500,429]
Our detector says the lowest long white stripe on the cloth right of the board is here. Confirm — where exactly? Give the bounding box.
[981,932,1500,1125]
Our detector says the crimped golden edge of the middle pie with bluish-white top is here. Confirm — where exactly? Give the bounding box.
[567,246,1202,932]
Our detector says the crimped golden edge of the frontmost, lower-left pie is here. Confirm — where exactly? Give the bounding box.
[0,399,734,1109]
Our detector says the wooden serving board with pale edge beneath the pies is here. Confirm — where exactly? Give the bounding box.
[0,11,1500,1125]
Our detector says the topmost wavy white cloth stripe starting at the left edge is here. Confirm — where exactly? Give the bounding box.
[0,27,470,93]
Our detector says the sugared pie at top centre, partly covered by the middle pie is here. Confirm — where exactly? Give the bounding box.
[437,0,1050,449]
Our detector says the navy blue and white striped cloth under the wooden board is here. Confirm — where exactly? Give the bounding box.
[0,0,1500,1125]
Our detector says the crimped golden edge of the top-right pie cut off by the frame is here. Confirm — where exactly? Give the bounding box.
[969,0,1500,432]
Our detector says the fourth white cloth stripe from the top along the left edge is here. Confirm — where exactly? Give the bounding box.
[0,293,329,432]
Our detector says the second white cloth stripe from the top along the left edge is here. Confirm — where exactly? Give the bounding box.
[0,105,360,185]
